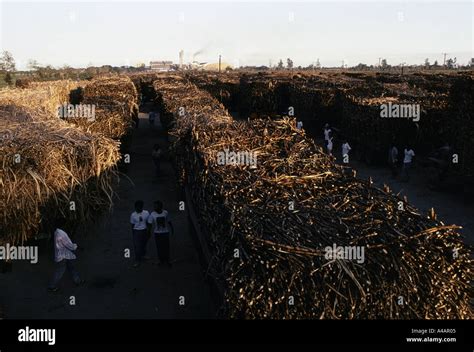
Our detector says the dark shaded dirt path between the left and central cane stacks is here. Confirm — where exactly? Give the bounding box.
[0,114,214,319]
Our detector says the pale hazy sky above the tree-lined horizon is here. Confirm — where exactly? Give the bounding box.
[0,0,474,69]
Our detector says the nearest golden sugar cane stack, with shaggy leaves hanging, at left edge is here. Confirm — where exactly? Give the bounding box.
[0,105,120,244]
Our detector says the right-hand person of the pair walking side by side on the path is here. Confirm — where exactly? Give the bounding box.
[147,200,174,266]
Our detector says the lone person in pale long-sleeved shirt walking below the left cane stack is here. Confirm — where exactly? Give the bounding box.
[48,219,84,292]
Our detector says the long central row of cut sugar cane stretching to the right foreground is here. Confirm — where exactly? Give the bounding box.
[154,75,472,319]
